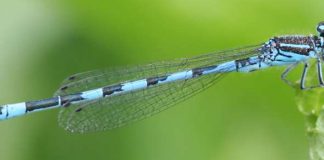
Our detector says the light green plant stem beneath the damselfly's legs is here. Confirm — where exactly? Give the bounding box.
[295,59,324,160]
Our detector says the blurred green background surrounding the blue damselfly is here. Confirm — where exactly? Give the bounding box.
[0,0,324,160]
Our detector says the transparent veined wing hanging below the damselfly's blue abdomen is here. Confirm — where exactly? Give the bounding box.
[59,74,224,133]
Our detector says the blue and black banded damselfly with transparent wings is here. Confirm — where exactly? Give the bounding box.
[0,22,324,133]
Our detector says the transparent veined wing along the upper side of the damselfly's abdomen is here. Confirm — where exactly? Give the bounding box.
[55,45,261,96]
